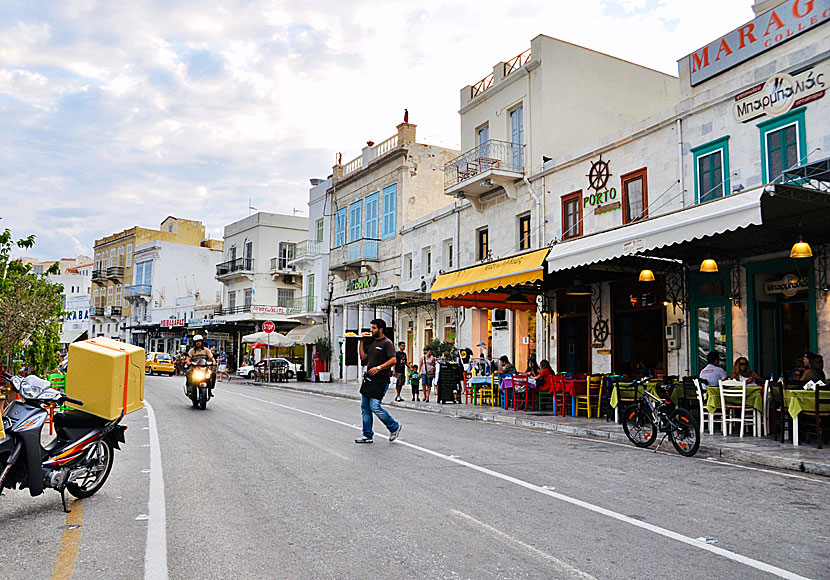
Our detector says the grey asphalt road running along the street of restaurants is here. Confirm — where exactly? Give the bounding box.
[0,377,830,580]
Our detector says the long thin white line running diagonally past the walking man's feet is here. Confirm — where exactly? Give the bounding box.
[219,391,808,580]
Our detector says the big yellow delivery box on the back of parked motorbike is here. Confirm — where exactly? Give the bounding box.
[66,337,145,420]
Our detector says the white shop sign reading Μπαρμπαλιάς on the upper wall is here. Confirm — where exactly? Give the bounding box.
[732,61,830,123]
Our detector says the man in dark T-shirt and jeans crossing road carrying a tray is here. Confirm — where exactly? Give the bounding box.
[354,318,401,443]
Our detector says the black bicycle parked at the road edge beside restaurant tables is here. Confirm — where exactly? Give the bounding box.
[623,382,700,457]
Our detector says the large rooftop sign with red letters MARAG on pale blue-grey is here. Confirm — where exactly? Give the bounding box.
[688,0,830,86]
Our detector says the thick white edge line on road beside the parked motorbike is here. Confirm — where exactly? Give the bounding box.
[144,401,167,580]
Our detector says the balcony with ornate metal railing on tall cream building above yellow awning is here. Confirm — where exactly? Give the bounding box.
[444,140,525,209]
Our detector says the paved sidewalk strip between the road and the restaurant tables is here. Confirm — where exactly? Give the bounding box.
[234,381,830,476]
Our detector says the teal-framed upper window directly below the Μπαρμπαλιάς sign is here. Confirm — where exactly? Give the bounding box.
[758,107,807,183]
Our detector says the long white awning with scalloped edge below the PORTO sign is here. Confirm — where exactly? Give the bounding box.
[548,187,764,272]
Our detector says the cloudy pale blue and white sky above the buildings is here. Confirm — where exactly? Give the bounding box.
[0,0,753,260]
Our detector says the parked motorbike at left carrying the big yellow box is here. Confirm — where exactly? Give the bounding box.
[0,373,127,512]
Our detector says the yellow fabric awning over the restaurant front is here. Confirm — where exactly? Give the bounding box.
[432,248,550,300]
